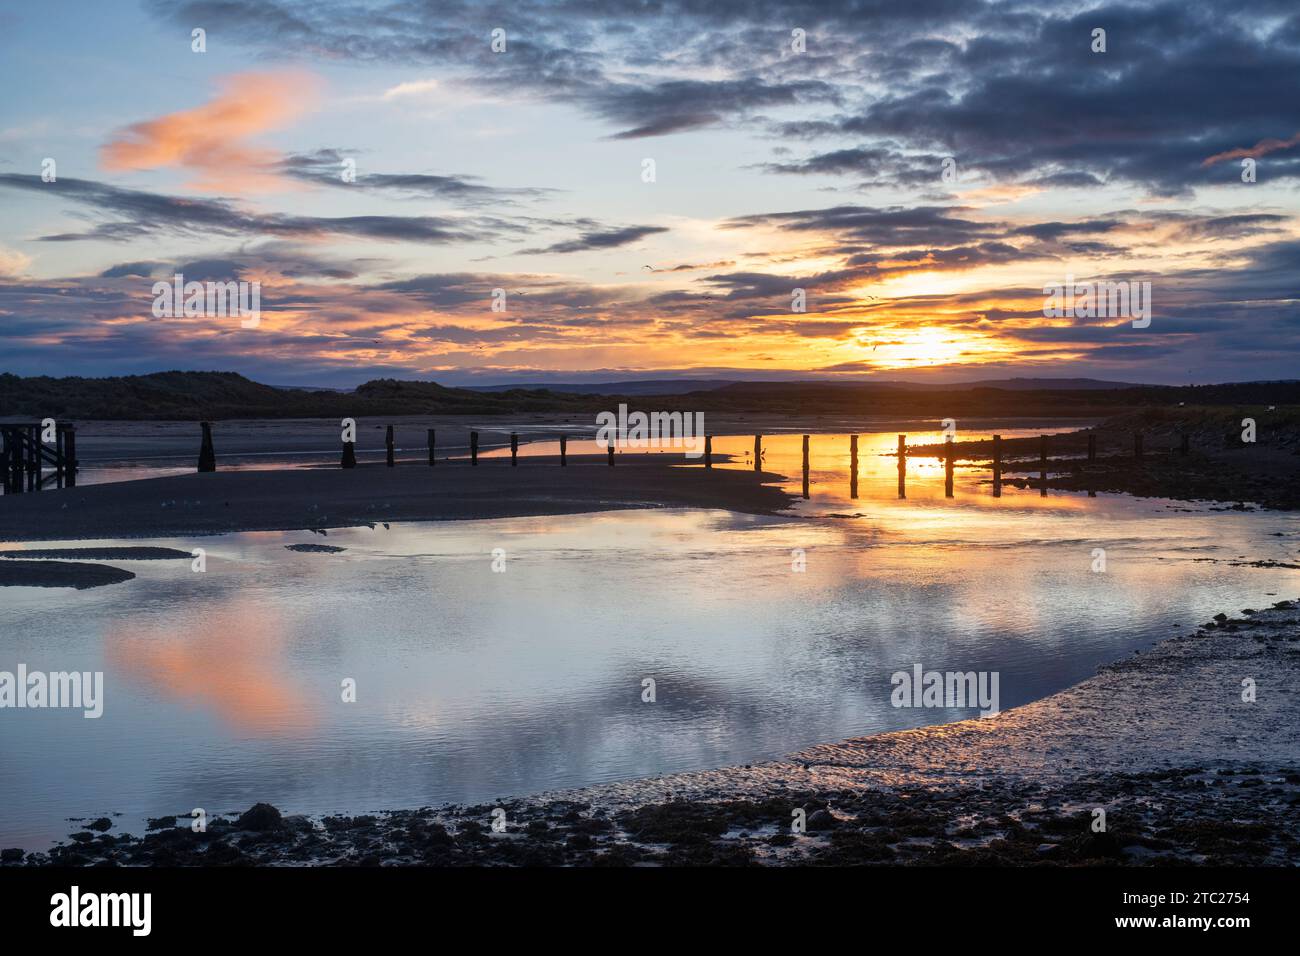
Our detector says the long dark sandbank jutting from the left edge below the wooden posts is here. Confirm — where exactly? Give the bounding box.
[0,455,792,541]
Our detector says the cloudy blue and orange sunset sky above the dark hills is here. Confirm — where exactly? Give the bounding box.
[0,0,1300,388]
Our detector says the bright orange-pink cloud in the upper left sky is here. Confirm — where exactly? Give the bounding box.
[100,72,320,193]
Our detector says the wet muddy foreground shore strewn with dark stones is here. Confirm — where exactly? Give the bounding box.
[12,601,1300,866]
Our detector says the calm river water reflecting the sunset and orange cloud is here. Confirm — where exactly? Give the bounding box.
[0,429,1300,848]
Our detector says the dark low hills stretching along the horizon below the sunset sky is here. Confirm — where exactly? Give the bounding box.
[0,372,1300,421]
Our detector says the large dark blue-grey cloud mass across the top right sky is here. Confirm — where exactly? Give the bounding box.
[151,0,1300,196]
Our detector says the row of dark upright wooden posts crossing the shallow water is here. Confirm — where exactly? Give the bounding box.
[199,421,1191,498]
